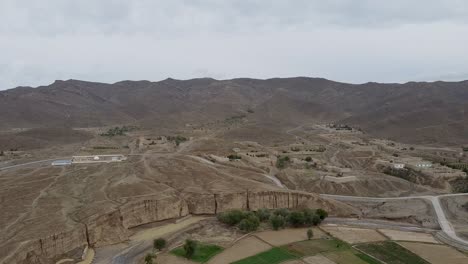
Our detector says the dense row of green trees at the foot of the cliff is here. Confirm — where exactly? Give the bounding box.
[218,208,328,232]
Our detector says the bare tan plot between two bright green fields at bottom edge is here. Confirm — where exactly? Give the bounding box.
[208,236,271,264]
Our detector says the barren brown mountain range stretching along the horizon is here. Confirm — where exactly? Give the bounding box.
[0,77,468,144]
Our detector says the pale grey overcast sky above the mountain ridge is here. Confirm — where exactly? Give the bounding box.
[0,0,468,90]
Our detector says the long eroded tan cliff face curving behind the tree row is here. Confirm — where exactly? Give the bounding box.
[2,191,356,264]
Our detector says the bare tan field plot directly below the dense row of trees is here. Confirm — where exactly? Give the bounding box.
[255,228,325,246]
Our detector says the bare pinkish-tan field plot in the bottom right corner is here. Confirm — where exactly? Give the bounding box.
[399,242,468,264]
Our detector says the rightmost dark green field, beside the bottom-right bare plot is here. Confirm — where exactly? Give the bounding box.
[357,241,429,264]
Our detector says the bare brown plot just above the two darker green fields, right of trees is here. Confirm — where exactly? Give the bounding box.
[322,225,387,244]
